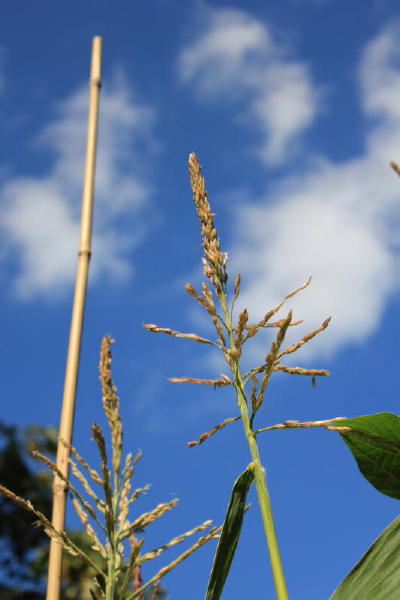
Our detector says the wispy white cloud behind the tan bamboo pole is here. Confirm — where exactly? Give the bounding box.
[0,77,152,299]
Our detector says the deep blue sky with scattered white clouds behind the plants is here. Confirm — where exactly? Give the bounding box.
[0,0,400,600]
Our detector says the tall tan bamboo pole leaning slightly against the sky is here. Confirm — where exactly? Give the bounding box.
[46,36,103,600]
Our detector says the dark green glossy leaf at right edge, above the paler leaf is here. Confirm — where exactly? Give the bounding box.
[334,413,400,496]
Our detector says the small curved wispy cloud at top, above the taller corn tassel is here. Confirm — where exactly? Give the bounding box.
[178,8,319,165]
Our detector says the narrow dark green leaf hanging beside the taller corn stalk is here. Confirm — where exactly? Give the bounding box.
[204,464,254,600]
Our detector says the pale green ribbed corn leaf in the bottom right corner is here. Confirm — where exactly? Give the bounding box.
[329,517,400,600]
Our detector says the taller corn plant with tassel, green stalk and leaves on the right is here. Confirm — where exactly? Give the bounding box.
[144,153,400,600]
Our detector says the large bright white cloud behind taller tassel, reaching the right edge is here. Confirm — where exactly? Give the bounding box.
[231,25,400,360]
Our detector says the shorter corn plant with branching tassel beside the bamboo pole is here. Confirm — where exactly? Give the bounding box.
[0,336,220,600]
